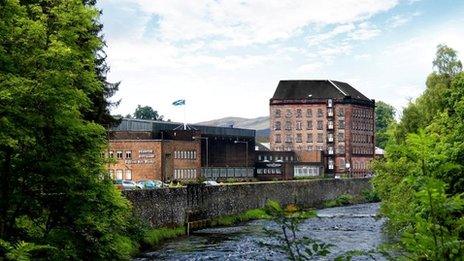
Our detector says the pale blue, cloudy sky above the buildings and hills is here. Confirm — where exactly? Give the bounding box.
[98,0,464,123]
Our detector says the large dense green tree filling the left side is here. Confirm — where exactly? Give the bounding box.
[0,0,134,260]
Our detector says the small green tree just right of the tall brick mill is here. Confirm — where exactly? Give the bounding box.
[375,101,395,148]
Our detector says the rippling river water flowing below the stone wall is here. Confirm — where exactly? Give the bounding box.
[136,203,386,260]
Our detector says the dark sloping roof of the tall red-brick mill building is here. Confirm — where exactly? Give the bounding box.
[272,80,370,101]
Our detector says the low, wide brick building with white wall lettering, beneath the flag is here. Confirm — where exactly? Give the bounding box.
[107,119,255,181]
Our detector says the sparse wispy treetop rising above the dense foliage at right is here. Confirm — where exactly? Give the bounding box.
[433,44,462,77]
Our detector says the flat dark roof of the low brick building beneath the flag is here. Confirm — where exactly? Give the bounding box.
[111,118,256,138]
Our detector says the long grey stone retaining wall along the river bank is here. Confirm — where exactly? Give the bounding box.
[123,179,371,227]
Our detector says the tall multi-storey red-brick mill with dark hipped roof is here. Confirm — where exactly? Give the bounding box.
[270,80,375,176]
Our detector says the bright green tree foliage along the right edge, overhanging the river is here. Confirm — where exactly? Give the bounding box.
[373,45,464,260]
